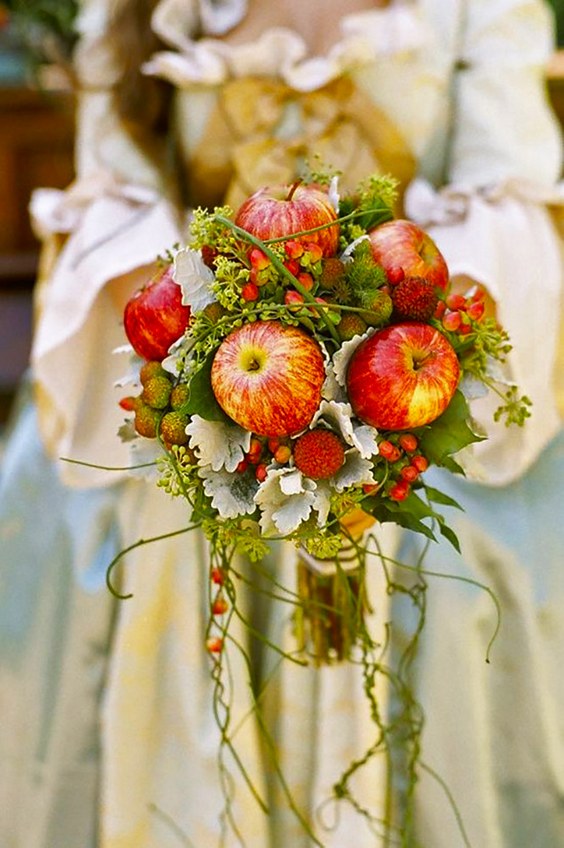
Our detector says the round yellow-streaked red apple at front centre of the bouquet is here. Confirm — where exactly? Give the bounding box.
[211,321,325,436]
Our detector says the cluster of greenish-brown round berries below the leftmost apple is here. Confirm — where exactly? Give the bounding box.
[120,360,189,448]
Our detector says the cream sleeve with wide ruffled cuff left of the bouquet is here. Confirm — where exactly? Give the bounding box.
[31,2,180,486]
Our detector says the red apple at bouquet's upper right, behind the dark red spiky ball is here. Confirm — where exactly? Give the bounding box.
[368,218,449,291]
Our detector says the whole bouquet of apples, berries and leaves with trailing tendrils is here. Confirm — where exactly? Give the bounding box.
[113,175,529,844]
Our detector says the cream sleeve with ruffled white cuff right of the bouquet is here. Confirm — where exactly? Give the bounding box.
[406,0,564,484]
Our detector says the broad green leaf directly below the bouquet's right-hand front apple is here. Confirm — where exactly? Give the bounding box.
[419,391,483,473]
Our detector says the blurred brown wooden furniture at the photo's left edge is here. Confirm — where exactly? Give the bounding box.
[0,87,74,426]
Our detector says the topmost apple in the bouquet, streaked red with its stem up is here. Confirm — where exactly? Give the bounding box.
[235,183,340,256]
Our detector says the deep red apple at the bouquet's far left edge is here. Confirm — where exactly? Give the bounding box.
[123,265,190,362]
